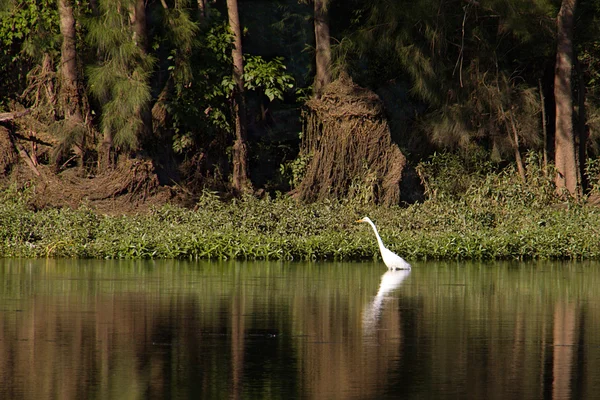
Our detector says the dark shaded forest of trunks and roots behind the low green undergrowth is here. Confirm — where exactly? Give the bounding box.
[0,0,600,211]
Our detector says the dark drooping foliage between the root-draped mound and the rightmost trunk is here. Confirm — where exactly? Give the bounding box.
[334,0,556,159]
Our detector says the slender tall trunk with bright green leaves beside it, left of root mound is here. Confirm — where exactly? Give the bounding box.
[227,0,252,193]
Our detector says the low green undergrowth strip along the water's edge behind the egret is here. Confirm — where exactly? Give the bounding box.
[0,152,600,261]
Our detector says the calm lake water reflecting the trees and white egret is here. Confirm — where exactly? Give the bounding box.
[0,260,600,400]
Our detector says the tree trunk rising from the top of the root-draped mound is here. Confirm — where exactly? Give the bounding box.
[314,0,331,97]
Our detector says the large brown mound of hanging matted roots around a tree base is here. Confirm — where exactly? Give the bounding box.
[296,75,406,205]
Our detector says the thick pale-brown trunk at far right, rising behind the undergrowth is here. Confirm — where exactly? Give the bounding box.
[554,0,580,198]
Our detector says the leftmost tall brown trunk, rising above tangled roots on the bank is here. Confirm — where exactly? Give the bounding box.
[58,0,85,165]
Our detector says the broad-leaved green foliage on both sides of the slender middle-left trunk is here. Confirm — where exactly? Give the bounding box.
[170,14,294,163]
